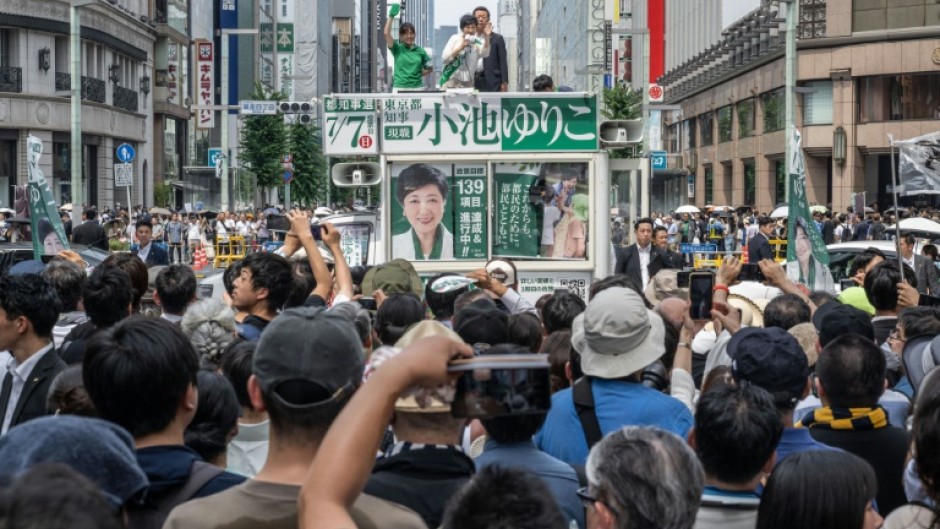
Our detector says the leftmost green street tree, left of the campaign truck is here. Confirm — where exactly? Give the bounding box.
[239,83,288,193]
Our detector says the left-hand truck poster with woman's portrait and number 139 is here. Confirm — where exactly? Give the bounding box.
[390,163,487,261]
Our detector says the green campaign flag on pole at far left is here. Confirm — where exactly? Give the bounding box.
[26,135,70,261]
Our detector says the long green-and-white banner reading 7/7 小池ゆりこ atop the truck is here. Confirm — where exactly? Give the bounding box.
[323,92,598,156]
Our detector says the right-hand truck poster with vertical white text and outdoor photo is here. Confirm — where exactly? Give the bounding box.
[493,162,590,259]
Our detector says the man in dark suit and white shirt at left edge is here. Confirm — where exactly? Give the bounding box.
[0,274,65,435]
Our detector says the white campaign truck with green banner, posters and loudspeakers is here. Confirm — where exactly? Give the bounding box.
[321,91,649,300]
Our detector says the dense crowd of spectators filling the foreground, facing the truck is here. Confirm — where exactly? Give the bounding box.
[0,205,940,529]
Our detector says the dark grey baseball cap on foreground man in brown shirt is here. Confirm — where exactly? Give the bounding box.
[252,307,363,410]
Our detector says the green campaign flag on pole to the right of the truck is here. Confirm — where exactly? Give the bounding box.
[787,126,835,292]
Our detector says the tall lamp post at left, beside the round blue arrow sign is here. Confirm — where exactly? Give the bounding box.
[69,0,98,226]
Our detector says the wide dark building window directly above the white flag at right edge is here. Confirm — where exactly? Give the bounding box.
[858,73,940,123]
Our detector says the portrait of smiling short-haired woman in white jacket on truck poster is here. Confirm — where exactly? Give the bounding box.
[392,163,454,261]
